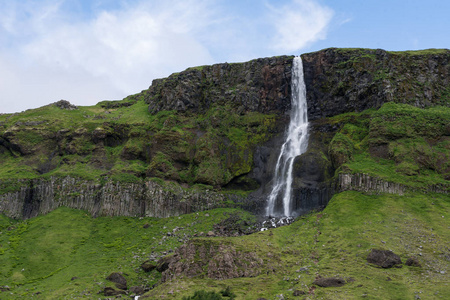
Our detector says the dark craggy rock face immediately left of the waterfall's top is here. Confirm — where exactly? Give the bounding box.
[145,56,293,113]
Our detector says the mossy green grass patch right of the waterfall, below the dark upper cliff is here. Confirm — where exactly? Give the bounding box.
[329,103,450,191]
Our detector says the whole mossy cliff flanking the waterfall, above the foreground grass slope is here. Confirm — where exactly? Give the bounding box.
[0,49,450,217]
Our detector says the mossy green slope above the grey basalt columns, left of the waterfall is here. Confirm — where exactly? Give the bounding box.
[0,96,277,189]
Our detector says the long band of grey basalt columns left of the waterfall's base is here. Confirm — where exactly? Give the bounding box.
[0,177,242,219]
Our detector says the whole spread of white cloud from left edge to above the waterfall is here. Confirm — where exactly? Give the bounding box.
[0,0,332,112]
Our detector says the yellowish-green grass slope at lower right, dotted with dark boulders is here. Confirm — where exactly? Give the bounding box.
[145,192,450,299]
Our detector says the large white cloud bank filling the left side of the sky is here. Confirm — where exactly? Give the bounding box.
[0,0,218,112]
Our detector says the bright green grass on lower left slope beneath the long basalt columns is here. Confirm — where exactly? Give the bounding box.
[0,208,250,299]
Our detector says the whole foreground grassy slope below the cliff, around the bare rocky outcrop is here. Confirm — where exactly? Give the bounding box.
[0,192,450,299]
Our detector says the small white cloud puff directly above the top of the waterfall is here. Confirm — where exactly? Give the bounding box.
[269,0,333,52]
